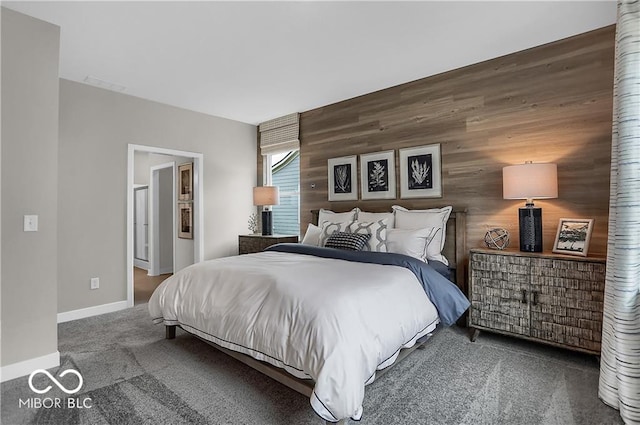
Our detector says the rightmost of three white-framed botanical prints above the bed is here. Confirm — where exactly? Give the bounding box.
[400,144,442,199]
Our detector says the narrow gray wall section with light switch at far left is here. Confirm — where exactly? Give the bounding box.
[1,8,60,366]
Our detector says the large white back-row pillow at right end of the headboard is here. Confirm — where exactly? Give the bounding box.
[391,205,453,265]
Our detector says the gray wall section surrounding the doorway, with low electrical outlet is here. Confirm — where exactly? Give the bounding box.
[58,79,257,312]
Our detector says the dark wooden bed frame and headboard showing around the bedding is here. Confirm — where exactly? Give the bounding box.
[165,210,467,425]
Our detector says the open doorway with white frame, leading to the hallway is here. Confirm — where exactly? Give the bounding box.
[127,144,204,307]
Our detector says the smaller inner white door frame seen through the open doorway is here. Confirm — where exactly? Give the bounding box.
[148,162,176,276]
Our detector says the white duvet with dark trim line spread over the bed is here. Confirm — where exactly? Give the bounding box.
[149,252,438,421]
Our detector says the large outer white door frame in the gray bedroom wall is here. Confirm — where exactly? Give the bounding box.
[127,143,204,307]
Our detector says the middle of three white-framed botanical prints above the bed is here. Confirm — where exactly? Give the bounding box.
[360,151,396,199]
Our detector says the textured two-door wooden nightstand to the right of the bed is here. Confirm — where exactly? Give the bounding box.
[468,249,606,355]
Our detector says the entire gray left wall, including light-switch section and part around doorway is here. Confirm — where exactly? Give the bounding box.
[0,8,256,372]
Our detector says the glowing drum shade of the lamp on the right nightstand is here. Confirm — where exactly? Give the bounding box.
[502,162,558,199]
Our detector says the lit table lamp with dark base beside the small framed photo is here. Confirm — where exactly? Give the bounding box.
[502,161,558,252]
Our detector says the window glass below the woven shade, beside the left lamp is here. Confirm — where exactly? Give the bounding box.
[264,150,300,235]
